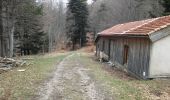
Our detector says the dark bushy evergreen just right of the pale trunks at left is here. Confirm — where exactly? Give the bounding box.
[15,0,44,55]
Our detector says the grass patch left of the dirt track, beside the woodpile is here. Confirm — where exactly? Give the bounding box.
[0,54,66,100]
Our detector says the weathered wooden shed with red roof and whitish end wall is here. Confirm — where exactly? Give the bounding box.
[95,16,170,79]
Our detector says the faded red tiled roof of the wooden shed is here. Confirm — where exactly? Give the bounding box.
[98,16,170,36]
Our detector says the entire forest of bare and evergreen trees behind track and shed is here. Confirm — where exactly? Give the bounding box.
[0,0,170,57]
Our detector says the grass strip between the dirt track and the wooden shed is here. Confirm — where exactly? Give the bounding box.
[81,54,170,100]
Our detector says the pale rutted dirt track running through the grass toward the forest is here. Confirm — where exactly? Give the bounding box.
[39,53,113,100]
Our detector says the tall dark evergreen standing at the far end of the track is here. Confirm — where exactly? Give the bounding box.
[66,0,88,49]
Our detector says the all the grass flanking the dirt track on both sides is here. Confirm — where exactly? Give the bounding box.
[0,53,170,100]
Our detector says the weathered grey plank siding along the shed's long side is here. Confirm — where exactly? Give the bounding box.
[97,37,151,79]
